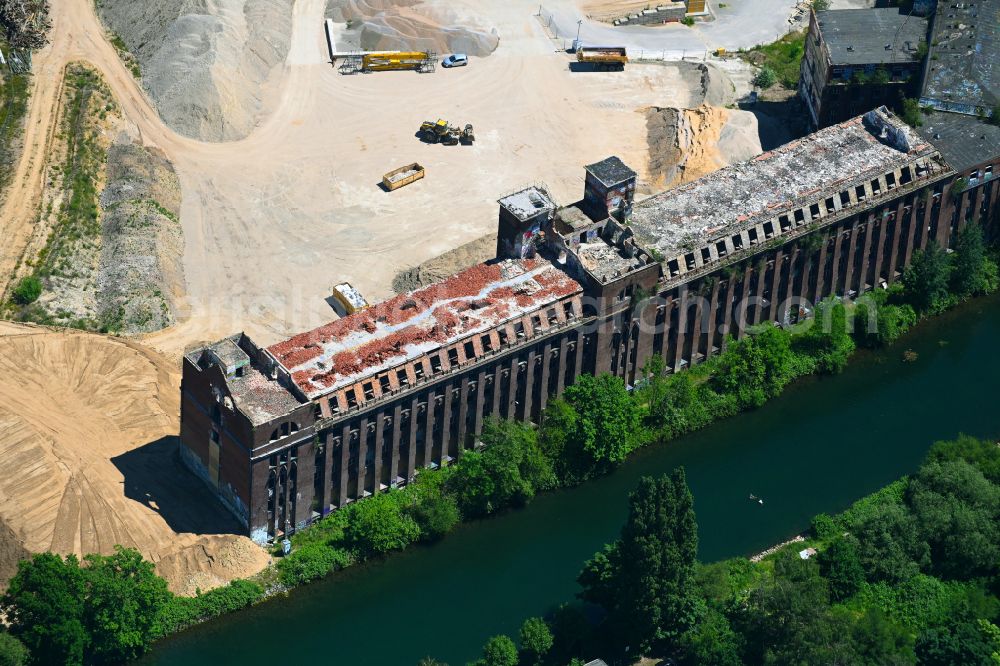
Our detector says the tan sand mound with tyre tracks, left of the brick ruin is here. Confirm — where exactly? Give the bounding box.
[0,324,268,592]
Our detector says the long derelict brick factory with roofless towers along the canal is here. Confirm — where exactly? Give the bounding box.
[180,108,1000,543]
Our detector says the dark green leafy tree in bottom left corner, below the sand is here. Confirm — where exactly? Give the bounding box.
[0,553,88,665]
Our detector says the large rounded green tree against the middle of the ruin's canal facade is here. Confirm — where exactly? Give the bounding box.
[563,373,641,472]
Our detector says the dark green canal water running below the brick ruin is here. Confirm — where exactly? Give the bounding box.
[141,298,1000,666]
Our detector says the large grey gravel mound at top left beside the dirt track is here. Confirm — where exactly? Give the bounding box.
[98,0,293,141]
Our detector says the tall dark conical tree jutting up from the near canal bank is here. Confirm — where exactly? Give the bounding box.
[580,468,698,650]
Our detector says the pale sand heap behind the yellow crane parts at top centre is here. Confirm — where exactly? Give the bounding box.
[327,0,500,56]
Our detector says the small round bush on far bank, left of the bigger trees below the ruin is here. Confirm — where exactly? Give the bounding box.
[344,490,420,555]
